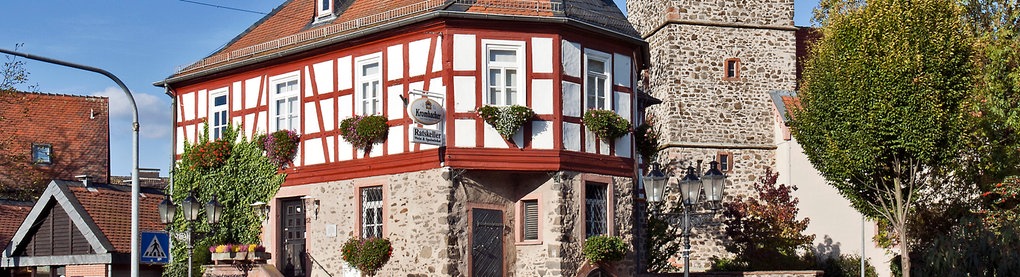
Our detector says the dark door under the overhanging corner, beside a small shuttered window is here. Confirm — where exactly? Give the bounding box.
[471,209,503,277]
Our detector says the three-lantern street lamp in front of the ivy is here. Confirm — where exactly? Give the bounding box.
[159,190,223,277]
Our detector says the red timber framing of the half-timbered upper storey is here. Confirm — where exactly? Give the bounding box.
[173,19,642,185]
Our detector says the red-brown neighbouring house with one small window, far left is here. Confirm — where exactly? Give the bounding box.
[0,92,110,200]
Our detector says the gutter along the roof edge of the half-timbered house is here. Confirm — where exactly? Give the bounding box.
[152,10,650,88]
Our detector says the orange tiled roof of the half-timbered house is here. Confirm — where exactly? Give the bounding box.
[155,0,644,86]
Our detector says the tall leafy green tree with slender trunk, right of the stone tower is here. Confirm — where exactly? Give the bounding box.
[794,0,972,276]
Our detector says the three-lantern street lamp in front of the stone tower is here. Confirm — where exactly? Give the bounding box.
[642,161,726,277]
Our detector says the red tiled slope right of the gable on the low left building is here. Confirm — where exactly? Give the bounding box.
[68,186,163,253]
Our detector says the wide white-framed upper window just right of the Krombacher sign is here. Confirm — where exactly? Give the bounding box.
[483,42,524,106]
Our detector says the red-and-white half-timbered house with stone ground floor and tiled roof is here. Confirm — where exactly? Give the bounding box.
[156,0,648,276]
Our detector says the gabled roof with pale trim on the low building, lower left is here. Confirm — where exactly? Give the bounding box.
[2,180,163,267]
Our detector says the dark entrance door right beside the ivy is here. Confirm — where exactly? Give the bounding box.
[277,199,307,277]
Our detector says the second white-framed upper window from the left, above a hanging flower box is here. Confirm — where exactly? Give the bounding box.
[269,73,301,133]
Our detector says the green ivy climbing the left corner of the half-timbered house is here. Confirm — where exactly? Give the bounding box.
[163,126,286,276]
